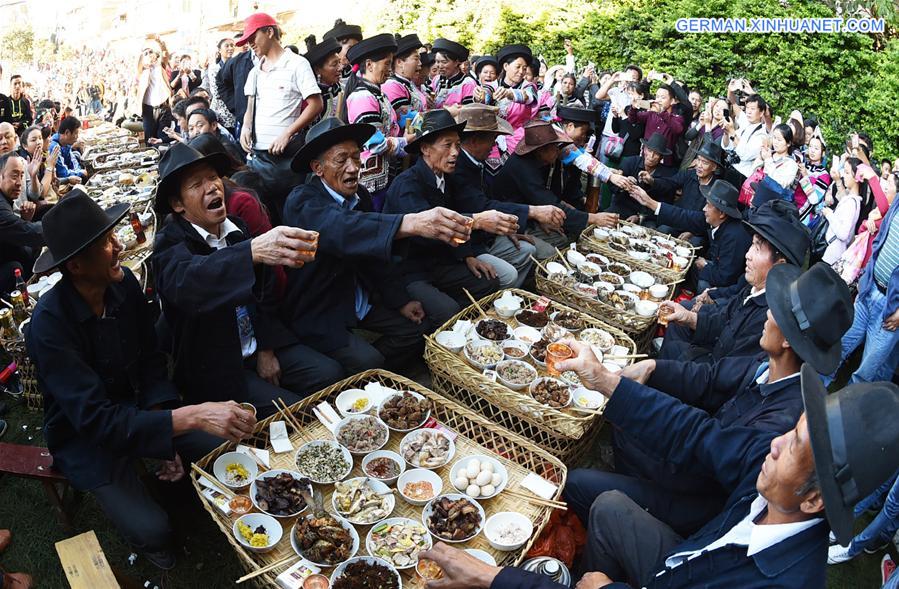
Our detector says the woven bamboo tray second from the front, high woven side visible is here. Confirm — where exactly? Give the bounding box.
[425,289,636,462]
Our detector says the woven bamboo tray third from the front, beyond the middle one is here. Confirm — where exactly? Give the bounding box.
[536,252,680,340]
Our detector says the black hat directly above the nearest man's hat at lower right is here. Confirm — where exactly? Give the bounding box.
[765,262,855,374]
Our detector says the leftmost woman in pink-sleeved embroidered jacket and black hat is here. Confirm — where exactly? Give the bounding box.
[341,33,406,211]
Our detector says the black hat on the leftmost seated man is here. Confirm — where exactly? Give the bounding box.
[33,188,131,274]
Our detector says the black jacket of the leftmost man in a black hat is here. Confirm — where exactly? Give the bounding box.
[26,268,178,490]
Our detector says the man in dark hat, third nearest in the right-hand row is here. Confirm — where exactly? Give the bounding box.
[659,200,809,362]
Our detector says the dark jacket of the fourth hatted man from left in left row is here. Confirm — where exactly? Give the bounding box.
[383,154,484,282]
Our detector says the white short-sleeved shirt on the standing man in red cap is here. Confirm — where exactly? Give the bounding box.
[244,49,321,150]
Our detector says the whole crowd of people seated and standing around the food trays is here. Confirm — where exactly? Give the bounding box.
[0,13,899,589]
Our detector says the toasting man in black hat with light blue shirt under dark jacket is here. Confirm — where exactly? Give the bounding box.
[283,118,469,375]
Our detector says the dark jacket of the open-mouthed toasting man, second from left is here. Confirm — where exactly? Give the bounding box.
[151,214,296,401]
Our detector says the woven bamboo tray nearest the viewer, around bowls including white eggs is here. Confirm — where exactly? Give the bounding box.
[191,370,568,587]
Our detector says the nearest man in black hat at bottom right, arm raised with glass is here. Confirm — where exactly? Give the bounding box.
[421,356,899,589]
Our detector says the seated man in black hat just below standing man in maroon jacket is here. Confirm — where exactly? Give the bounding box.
[606,133,676,223]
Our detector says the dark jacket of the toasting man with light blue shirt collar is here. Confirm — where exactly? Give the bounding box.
[282,177,411,352]
